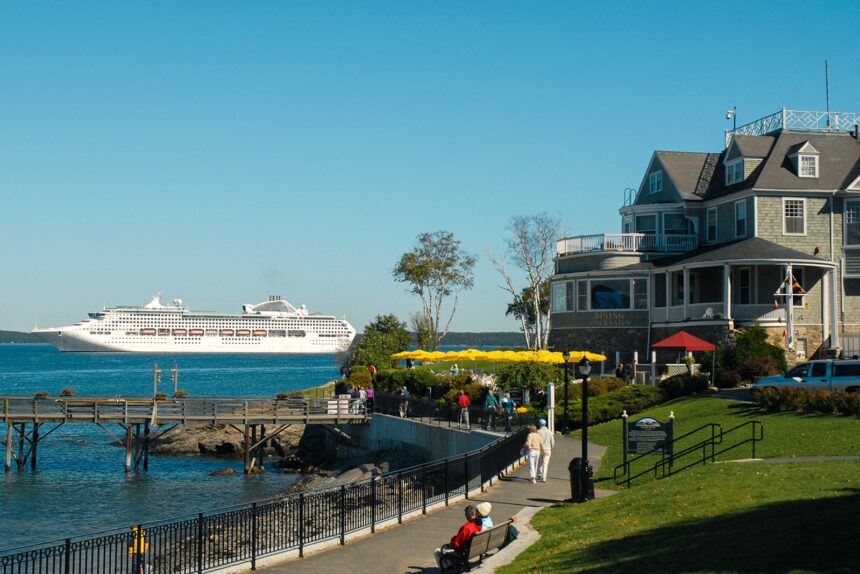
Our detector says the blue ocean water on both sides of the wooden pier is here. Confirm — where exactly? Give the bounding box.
[0,345,339,550]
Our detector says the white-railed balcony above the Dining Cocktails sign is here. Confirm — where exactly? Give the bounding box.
[557,233,698,256]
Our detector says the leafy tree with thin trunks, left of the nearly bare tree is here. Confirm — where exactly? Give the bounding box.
[392,231,475,349]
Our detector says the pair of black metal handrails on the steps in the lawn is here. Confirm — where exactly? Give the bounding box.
[612,421,764,488]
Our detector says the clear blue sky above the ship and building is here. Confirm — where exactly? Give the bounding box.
[0,1,860,331]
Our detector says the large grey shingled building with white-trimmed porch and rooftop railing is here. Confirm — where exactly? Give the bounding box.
[550,109,860,361]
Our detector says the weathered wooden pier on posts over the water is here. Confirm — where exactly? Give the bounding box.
[0,395,368,473]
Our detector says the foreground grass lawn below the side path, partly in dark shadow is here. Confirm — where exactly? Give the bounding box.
[499,461,860,574]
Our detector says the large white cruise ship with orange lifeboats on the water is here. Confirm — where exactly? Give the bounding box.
[33,293,355,354]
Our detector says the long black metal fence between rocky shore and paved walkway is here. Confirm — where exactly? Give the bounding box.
[0,430,525,574]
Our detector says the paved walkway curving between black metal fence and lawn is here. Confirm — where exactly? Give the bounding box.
[257,436,609,574]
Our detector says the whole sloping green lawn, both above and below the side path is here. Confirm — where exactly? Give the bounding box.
[499,397,860,574]
